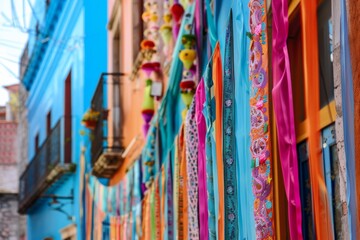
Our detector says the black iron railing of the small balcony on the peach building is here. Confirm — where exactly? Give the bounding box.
[91,73,123,166]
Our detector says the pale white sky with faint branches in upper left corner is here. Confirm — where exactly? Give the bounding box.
[0,0,34,106]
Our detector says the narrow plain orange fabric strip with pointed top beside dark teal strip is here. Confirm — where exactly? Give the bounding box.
[213,42,225,240]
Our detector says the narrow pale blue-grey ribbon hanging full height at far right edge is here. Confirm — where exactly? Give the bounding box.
[340,0,358,239]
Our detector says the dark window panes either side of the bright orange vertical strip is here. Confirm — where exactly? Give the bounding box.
[288,0,342,239]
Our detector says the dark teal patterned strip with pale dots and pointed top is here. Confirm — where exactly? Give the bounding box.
[221,11,239,239]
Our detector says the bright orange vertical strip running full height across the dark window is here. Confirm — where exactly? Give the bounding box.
[301,0,334,239]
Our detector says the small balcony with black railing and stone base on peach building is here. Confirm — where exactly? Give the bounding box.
[91,73,124,178]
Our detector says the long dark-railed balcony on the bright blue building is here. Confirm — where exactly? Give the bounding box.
[19,117,75,214]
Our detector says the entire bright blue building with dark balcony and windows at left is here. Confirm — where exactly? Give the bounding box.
[19,0,107,240]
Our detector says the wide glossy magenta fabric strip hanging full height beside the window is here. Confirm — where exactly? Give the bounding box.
[272,0,302,240]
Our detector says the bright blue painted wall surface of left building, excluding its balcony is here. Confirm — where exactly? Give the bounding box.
[27,0,107,240]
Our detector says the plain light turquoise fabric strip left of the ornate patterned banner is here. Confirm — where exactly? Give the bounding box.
[233,0,256,239]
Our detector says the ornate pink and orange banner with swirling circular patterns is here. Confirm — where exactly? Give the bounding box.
[249,0,274,239]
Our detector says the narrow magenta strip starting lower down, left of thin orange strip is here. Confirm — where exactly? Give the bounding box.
[195,79,209,239]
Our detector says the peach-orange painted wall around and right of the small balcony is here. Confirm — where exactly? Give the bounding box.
[108,0,165,185]
